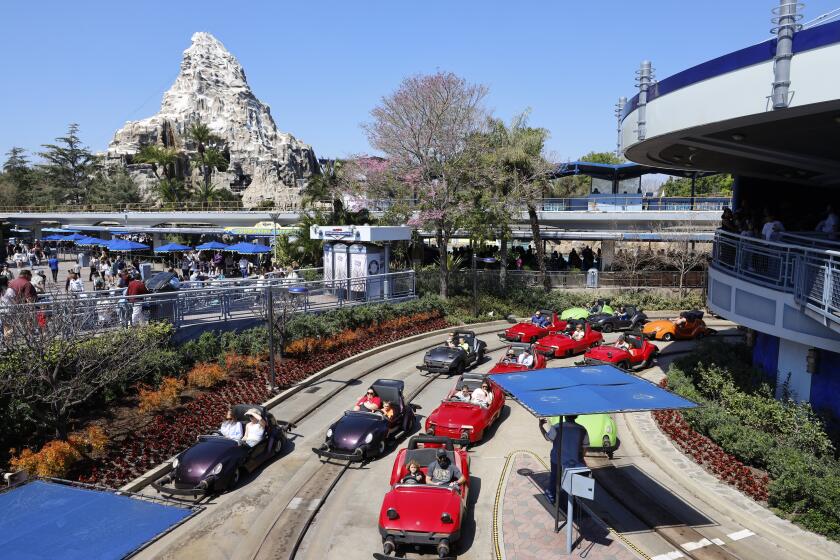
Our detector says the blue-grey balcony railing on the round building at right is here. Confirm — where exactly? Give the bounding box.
[712,231,840,323]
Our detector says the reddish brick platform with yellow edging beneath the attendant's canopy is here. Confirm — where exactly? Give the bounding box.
[493,451,645,560]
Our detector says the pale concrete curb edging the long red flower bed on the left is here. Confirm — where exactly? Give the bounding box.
[119,320,509,492]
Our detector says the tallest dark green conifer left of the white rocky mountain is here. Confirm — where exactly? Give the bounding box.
[38,123,98,204]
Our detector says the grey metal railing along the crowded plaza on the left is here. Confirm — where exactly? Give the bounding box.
[14,270,416,330]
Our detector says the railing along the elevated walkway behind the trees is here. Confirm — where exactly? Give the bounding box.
[351,195,732,212]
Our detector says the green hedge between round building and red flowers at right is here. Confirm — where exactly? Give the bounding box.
[668,341,840,540]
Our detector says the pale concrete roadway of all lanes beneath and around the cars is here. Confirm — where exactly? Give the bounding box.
[138,317,792,560]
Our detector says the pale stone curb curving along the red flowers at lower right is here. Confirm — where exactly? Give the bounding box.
[626,413,837,560]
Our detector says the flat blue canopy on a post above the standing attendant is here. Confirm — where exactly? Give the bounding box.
[490,365,699,418]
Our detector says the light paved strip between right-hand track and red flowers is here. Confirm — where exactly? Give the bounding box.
[625,367,840,560]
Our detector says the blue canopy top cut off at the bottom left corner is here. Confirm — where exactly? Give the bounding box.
[0,480,193,560]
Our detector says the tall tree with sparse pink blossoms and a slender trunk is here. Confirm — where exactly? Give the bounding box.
[363,72,487,297]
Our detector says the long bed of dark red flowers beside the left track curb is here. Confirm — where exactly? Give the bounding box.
[79,315,447,487]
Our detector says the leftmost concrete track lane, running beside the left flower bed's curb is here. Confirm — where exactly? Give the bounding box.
[138,323,504,560]
